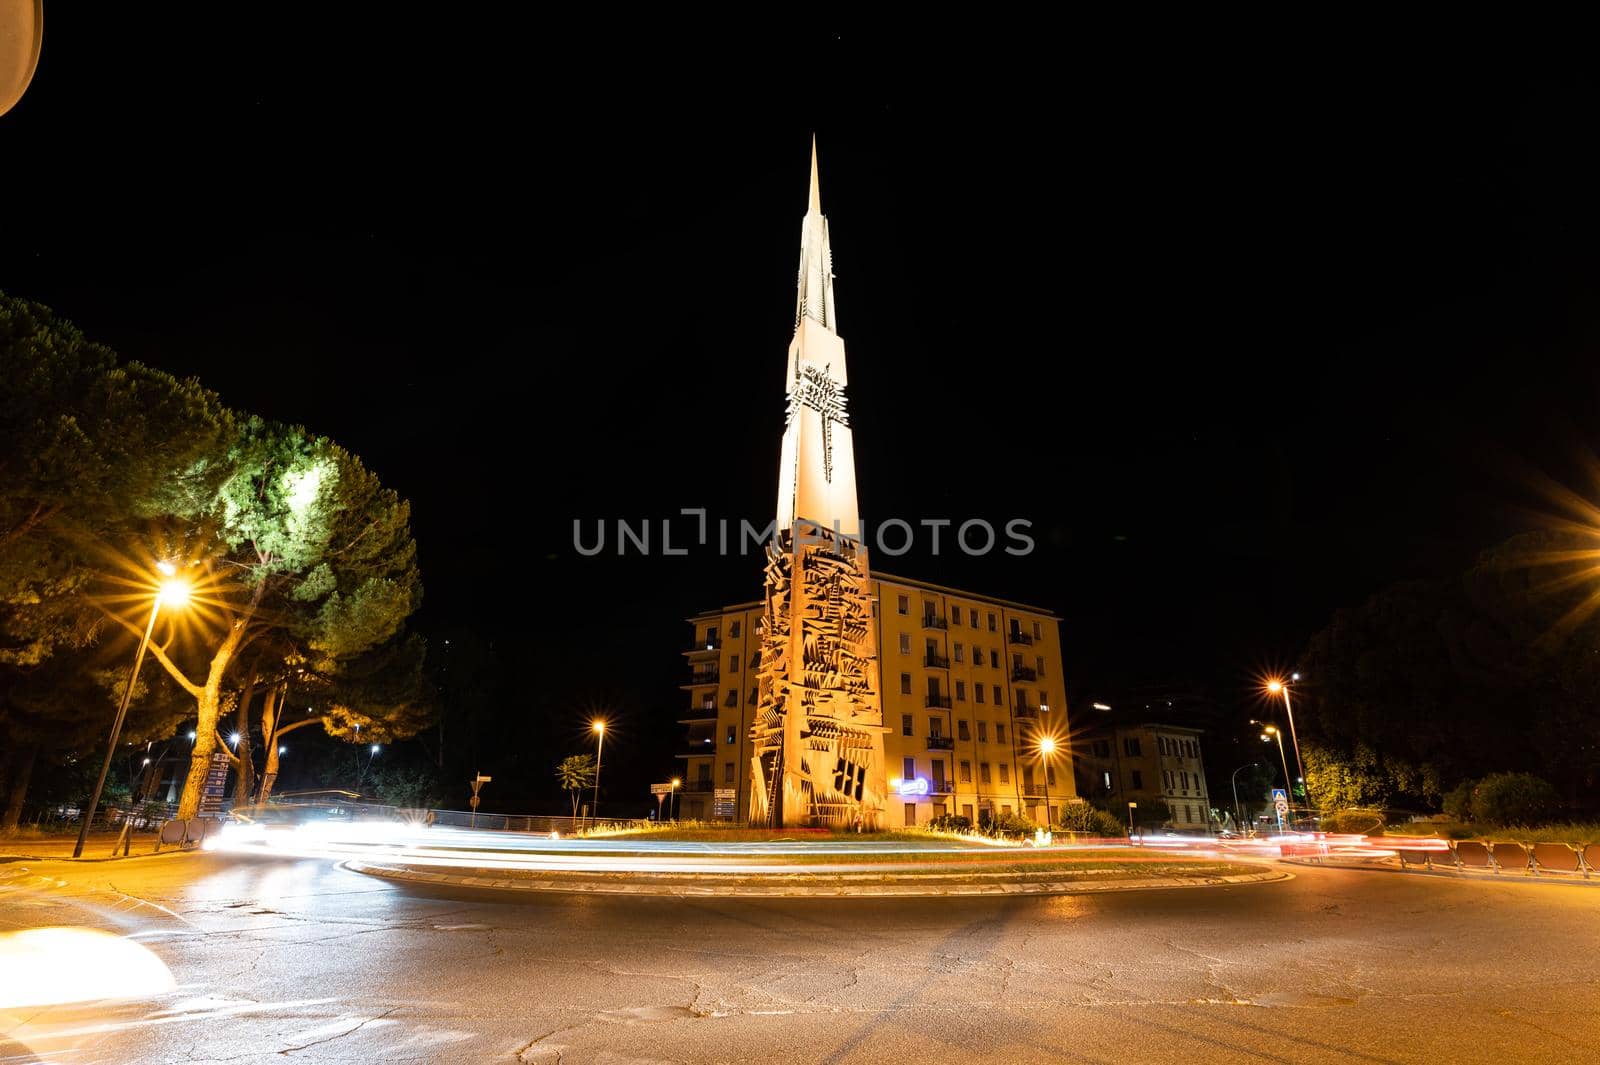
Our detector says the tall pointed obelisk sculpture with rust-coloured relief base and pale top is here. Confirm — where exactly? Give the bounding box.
[750,139,886,828]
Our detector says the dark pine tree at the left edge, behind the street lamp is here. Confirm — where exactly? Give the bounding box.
[0,293,232,812]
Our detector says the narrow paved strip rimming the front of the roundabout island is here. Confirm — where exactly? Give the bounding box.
[342,859,1294,899]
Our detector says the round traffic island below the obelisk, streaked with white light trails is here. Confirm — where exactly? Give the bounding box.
[214,822,1290,897]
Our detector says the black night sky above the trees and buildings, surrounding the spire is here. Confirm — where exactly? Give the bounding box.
[0,14,1600,805]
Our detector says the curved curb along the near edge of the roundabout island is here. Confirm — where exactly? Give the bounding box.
[339,859,1294,899]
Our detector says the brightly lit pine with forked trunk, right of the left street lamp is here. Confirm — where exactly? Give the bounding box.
[94,417,422,817]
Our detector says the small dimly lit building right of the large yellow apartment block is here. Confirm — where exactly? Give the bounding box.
[1072,723,1214,832]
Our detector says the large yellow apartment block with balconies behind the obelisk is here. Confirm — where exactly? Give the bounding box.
[678,572,1077,827]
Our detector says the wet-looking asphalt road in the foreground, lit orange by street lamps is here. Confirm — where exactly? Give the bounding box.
[0,854,1600,1065]
